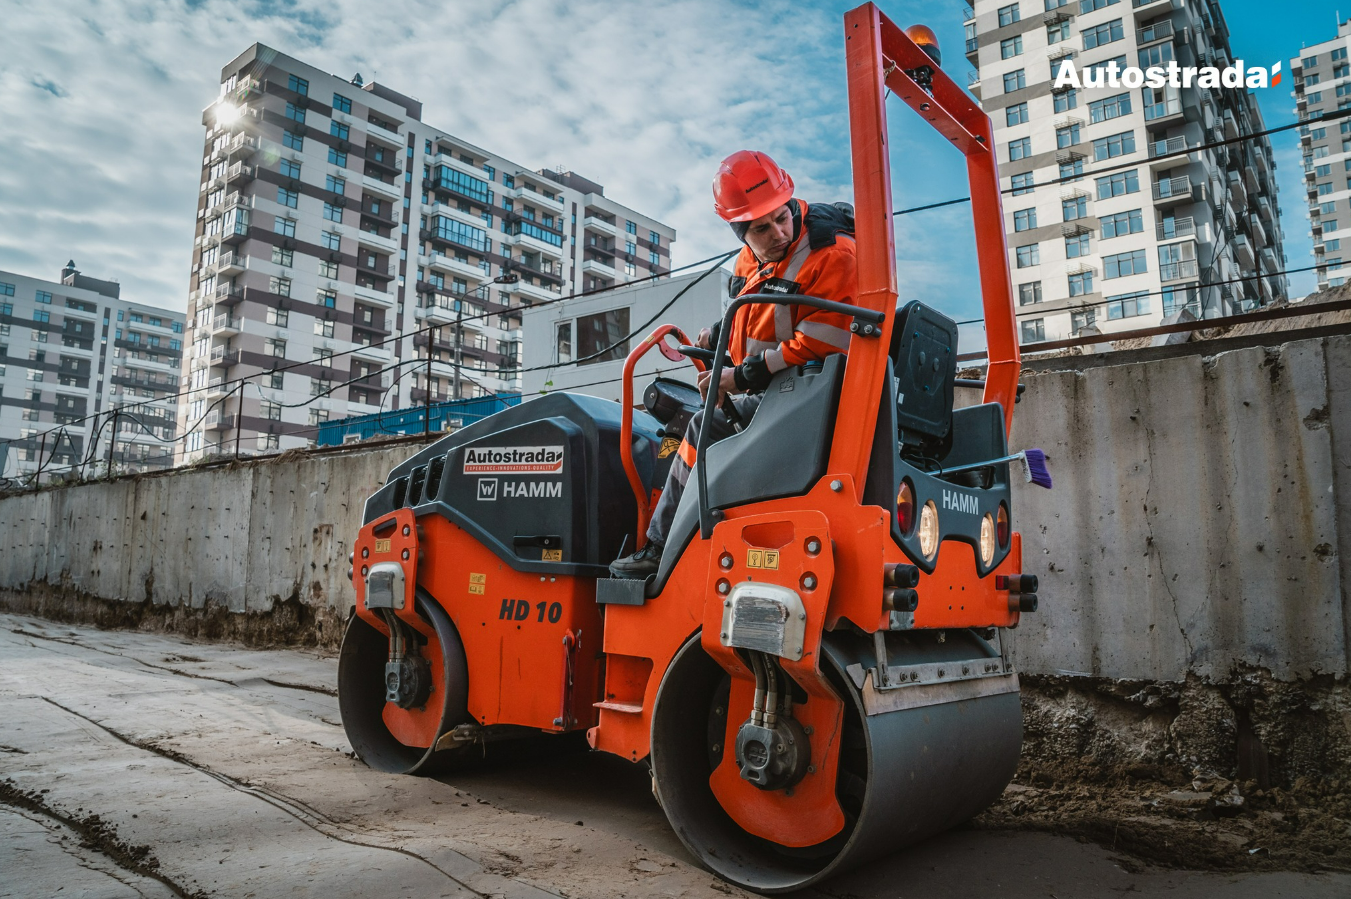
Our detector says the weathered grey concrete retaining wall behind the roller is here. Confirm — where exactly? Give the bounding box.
[0,335,1351,681]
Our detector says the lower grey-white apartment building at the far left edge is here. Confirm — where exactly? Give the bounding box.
[0,261,185,479]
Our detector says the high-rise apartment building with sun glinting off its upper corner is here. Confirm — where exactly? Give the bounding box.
[181,45,676,458]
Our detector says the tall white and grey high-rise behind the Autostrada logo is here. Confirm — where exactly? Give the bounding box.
[966,0,1286,343]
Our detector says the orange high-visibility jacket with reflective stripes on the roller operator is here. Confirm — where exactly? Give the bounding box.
[727,201,858,383]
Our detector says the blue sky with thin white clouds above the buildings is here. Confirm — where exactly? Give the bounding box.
[0,0,1351,340]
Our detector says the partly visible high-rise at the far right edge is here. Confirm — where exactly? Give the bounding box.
[1290,20,1351,289]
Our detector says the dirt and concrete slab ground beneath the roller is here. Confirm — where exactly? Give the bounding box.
[0,605,1351,899]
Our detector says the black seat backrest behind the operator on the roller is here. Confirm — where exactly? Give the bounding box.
[892,300,957,458]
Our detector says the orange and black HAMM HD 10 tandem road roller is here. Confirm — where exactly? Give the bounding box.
[339,4,1036,892]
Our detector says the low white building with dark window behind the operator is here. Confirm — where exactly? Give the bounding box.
[521,268,731,403]
